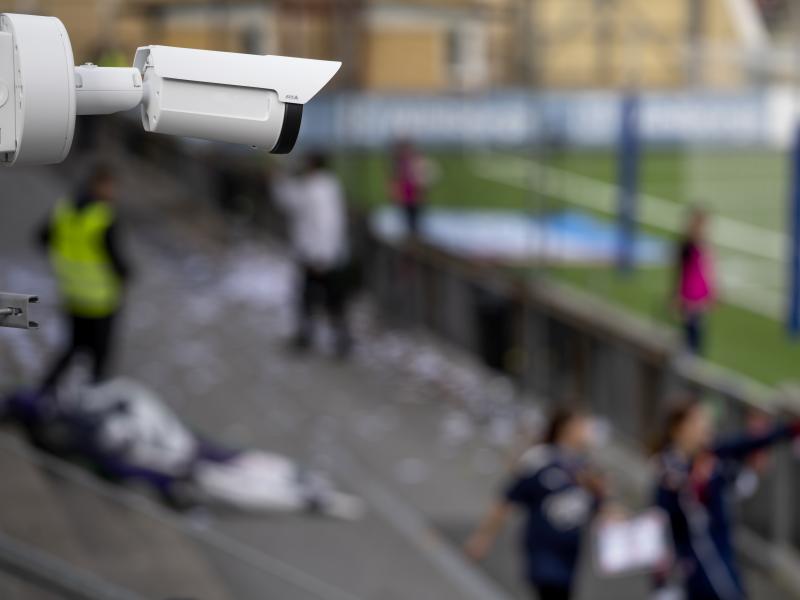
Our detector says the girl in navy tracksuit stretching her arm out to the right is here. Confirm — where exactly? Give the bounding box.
[655,400,798,600]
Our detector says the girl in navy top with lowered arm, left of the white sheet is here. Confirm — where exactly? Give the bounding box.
[466,410,603,600]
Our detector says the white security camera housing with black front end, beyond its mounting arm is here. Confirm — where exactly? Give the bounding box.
[133,46,341,153]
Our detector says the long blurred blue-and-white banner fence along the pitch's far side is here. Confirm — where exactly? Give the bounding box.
[301,90,780,148]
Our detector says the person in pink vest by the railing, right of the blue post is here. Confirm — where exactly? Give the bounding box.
[673,208,717,354]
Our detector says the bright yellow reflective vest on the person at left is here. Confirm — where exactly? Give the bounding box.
[50,201,122,318]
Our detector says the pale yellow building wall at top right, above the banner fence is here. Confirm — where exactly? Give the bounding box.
[531,0,742,88]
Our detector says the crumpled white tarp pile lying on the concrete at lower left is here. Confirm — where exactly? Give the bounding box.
[73,379,363,519]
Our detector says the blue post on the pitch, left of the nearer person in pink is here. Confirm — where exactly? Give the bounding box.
[617,91,639,274]
